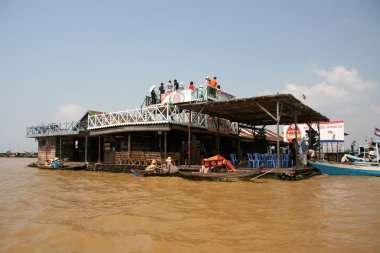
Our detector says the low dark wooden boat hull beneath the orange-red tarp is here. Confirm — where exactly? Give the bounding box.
[177,169,261,182]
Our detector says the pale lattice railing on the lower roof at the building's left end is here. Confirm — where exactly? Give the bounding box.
[26,121,80,137]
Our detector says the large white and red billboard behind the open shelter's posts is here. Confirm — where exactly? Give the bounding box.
[284,121,344,142]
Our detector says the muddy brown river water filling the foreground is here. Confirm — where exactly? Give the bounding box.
[0,158,380,252]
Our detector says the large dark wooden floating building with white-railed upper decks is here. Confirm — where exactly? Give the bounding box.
[26,88,328,168]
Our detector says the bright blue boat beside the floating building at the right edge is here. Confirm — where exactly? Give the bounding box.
[309,161,380,176]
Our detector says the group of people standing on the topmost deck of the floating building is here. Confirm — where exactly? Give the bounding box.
[150,76,220,104]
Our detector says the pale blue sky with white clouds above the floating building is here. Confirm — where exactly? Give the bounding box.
[0,0,380,152]
